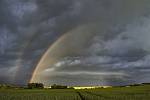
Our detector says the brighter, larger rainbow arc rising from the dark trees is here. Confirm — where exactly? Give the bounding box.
[29,23,98,82]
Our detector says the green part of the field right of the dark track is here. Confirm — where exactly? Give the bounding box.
[77,86,150,100]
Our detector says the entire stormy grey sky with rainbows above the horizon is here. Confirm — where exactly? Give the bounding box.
[0,0,150,85]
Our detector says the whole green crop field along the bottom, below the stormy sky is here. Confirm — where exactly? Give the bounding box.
[0,85,150,100]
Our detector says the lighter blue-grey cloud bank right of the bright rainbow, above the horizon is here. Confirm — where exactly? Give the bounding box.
[44,15,150,85]
